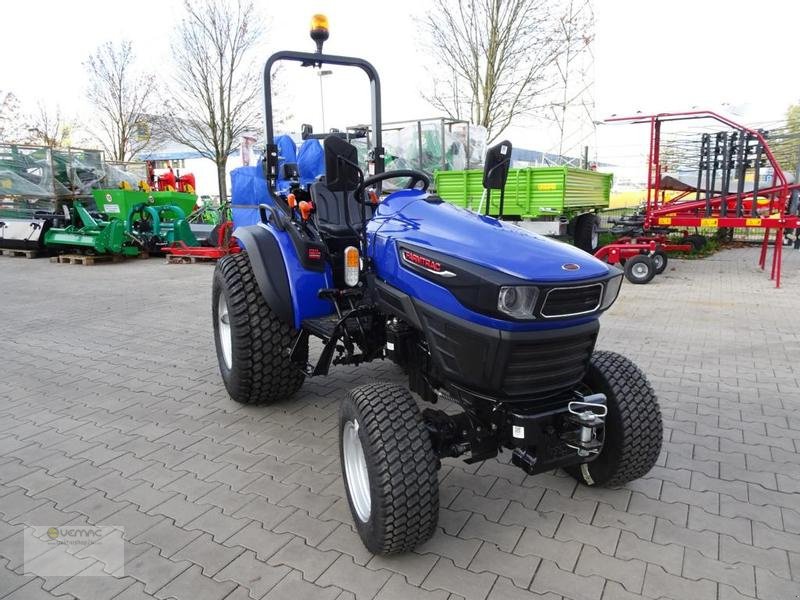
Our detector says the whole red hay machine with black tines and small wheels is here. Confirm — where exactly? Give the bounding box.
[595,111,800,287]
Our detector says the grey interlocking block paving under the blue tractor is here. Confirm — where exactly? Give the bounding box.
[0,250,800,600]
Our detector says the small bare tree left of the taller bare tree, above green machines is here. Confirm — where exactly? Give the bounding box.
[84,40,156,161]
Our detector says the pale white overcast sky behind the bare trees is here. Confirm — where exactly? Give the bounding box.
[0,0,800,173]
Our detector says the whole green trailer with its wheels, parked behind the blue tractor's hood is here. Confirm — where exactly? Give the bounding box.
[434,167,612,252]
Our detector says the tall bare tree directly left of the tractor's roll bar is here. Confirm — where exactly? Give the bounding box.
[165,0,263,200]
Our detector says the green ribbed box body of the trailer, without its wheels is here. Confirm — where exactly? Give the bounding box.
[434,167,612,219]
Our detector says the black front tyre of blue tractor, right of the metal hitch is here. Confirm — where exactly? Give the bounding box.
[565,351,664,486]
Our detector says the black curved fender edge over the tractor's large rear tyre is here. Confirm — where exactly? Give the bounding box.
[233,225,295,327]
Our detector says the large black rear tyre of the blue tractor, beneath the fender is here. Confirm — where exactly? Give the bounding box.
[211,252,307,404]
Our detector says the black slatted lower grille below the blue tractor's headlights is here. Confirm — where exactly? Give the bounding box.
[503,328,597,398]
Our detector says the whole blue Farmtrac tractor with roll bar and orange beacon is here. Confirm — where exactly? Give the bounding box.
[212,17,662,553]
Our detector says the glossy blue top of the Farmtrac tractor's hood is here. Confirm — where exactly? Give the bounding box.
[369,190,610,282]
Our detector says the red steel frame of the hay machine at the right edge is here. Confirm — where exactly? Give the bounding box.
[595,111,800,287]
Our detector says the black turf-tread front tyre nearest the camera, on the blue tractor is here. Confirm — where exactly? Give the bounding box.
[339,382,439,554]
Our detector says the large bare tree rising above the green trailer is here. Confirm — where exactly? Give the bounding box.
[424,0,563,141]
